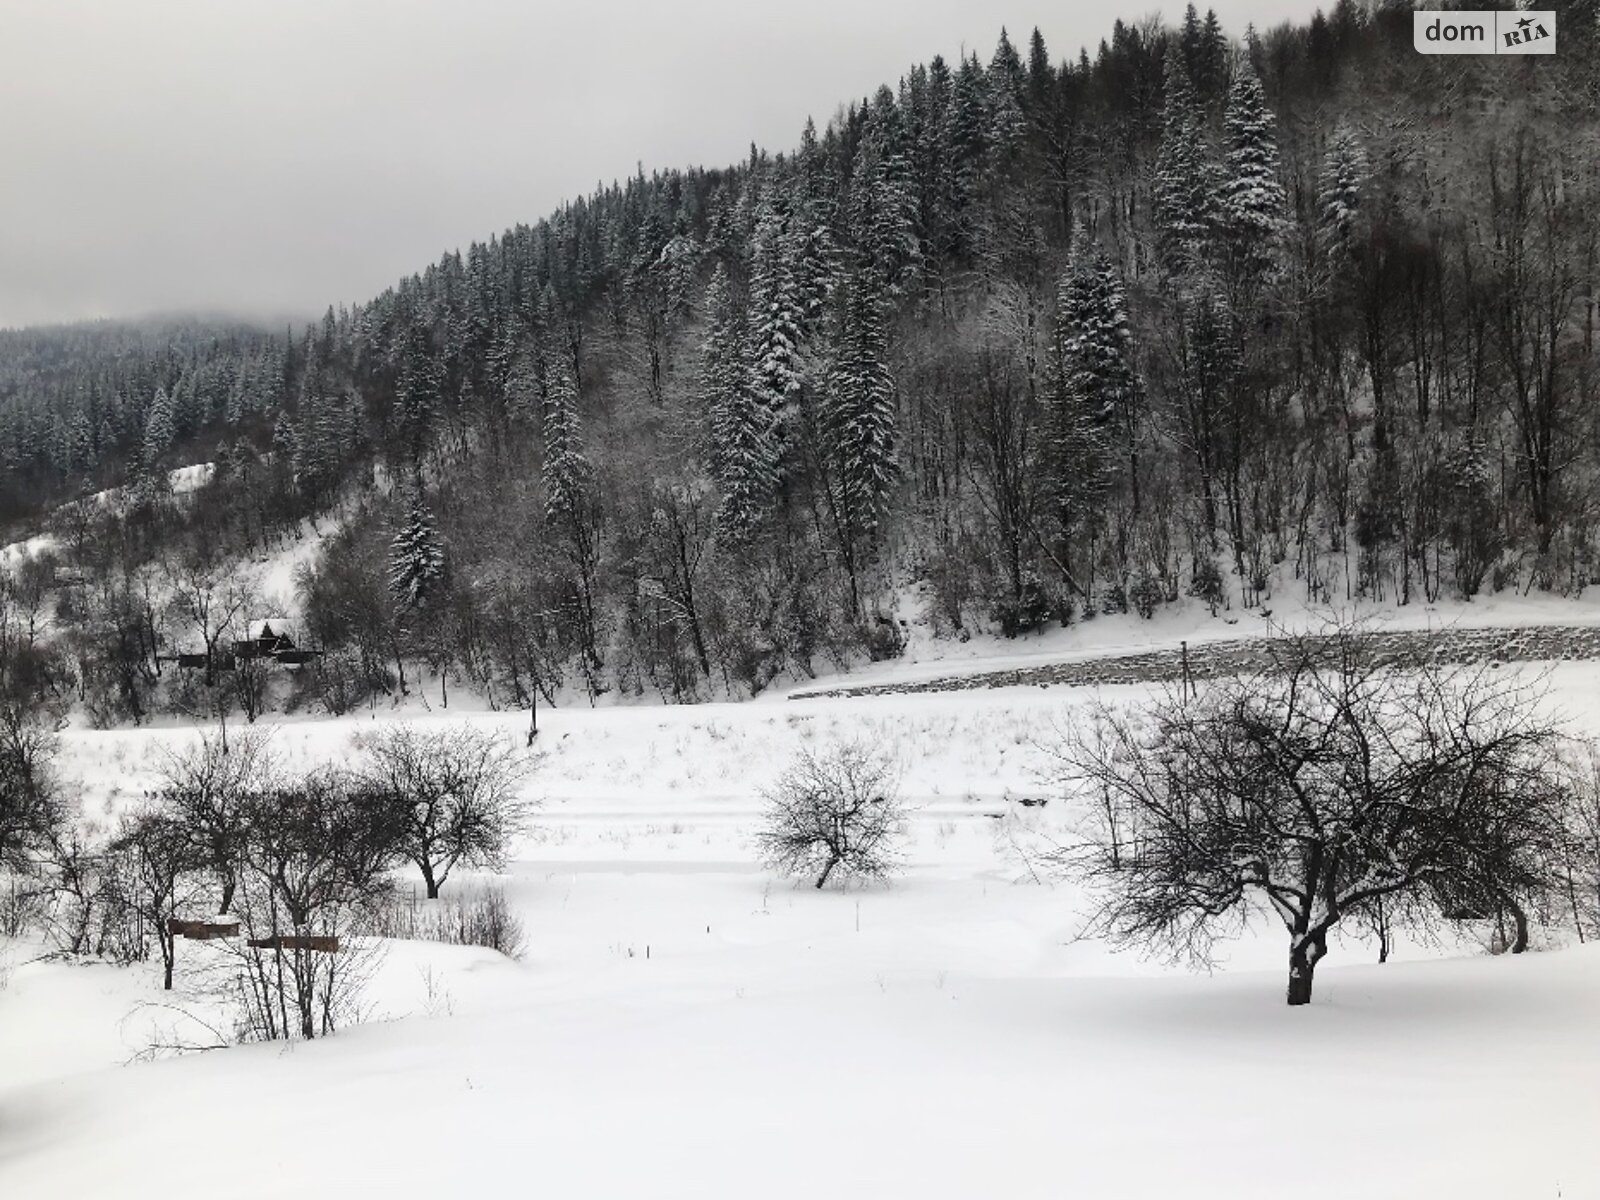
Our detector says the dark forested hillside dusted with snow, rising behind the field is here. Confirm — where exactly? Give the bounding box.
[0,0,1600,722]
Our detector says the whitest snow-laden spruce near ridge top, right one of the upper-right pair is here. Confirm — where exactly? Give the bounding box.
[1219,54,1288,275]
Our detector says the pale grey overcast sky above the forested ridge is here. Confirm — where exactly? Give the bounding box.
[0,0,1317,326]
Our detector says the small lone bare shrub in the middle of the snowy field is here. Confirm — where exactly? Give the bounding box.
[755,742,906,888]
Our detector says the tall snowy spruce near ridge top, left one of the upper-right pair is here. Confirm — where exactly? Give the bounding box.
[1152,43,1218,272]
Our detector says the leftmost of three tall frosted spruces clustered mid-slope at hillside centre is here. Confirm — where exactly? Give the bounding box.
[701,266,778,542]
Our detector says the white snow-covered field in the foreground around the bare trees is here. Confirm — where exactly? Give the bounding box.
[0,664,1600,1200]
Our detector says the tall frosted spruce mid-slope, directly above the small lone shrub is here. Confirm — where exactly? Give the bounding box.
[818,270,898,611]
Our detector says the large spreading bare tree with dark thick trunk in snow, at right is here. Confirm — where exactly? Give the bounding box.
[1058,629,1565,1005]
